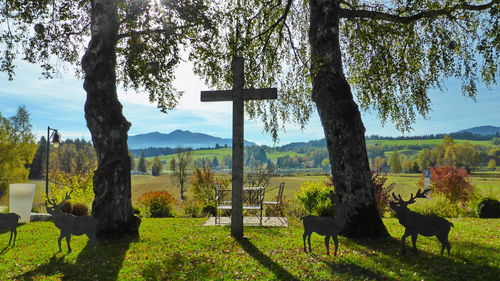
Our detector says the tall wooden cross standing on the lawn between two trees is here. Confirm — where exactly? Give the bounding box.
[201,57,278,238]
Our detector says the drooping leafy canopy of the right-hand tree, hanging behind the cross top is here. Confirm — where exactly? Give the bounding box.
[192,0,500,138]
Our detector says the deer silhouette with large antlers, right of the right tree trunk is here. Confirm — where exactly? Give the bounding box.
[389,189,453,256]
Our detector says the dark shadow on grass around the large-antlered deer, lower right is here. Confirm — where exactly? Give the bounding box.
[351,237,500,281]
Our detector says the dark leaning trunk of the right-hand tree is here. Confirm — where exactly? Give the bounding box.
[309,0,389,238]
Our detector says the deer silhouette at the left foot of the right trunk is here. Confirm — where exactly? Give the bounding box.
[301,191,351,256]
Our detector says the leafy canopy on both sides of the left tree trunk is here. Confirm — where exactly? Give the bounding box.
[0,0,210,112]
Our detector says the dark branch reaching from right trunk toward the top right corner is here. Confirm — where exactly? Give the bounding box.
[339,0,499,24]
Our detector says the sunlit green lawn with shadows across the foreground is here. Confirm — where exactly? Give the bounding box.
[0,218,500,280]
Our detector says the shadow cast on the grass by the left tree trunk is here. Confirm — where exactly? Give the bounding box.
[14,238,136,280]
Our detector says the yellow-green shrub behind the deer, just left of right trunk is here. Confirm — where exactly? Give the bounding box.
[296,181,333,214]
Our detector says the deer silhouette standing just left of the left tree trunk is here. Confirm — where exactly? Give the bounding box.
[46,192,97,253]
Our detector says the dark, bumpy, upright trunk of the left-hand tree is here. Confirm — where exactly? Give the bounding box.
[82,0,140,238]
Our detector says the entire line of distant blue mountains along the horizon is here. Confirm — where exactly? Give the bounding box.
[128,126,500,150]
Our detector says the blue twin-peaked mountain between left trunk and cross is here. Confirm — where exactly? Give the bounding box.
[128,130,257,149]
